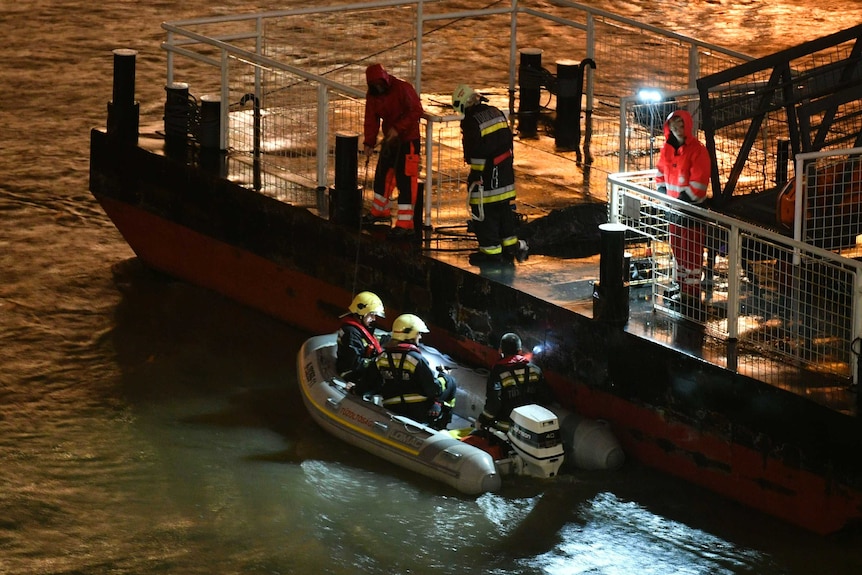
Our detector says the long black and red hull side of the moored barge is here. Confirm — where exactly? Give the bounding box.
[90,130,862,533]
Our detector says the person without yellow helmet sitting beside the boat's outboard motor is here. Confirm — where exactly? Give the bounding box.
[476,333,554,433]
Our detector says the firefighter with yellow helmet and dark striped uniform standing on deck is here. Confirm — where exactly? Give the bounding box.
[452,84,528,265]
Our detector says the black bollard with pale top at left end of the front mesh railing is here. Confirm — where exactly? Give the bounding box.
[593,224,629,326]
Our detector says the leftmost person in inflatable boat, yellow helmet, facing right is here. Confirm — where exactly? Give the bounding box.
[335,291,386,382]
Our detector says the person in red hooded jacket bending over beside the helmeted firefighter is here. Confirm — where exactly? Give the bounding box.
[363,64,423,237]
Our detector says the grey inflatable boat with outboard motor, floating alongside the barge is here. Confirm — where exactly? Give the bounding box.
[297,333,625,495]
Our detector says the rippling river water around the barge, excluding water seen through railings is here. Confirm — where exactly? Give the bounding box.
[5,0,862,575]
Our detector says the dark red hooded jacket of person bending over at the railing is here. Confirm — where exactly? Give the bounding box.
[363,64,423,148]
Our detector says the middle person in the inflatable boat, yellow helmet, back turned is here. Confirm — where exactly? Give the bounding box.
[365,313,456,429]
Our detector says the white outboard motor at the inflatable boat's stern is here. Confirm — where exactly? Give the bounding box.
[507,404,564,478]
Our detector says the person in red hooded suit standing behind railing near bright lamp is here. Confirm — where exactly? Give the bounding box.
[655,110,711,303]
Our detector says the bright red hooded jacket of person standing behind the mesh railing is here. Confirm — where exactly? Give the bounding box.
[655,110,712,204]
